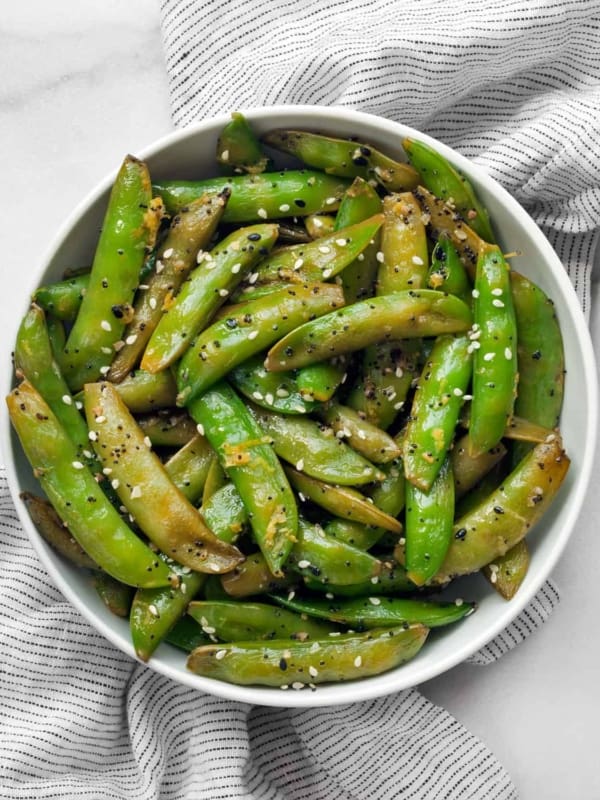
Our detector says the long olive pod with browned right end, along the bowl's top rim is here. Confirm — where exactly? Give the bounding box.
[261,129,419,191]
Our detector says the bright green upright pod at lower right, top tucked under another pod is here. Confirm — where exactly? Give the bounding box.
[404,458,454,586]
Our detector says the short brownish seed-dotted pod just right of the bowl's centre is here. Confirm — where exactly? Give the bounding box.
[320,401,401,464]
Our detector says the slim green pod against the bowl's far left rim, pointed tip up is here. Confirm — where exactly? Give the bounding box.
[14,305,92,460]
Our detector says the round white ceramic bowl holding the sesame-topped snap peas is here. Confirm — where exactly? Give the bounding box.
[0,106,598,706]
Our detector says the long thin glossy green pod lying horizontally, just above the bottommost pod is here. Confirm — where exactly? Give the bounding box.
[271,594,475,631]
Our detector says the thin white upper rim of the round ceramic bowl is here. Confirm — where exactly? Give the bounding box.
[0,105,598,707]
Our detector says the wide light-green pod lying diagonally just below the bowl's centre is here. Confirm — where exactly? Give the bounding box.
[250,406,383,486]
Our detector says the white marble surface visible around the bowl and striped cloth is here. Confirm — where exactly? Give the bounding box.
[0,0,600,800]
